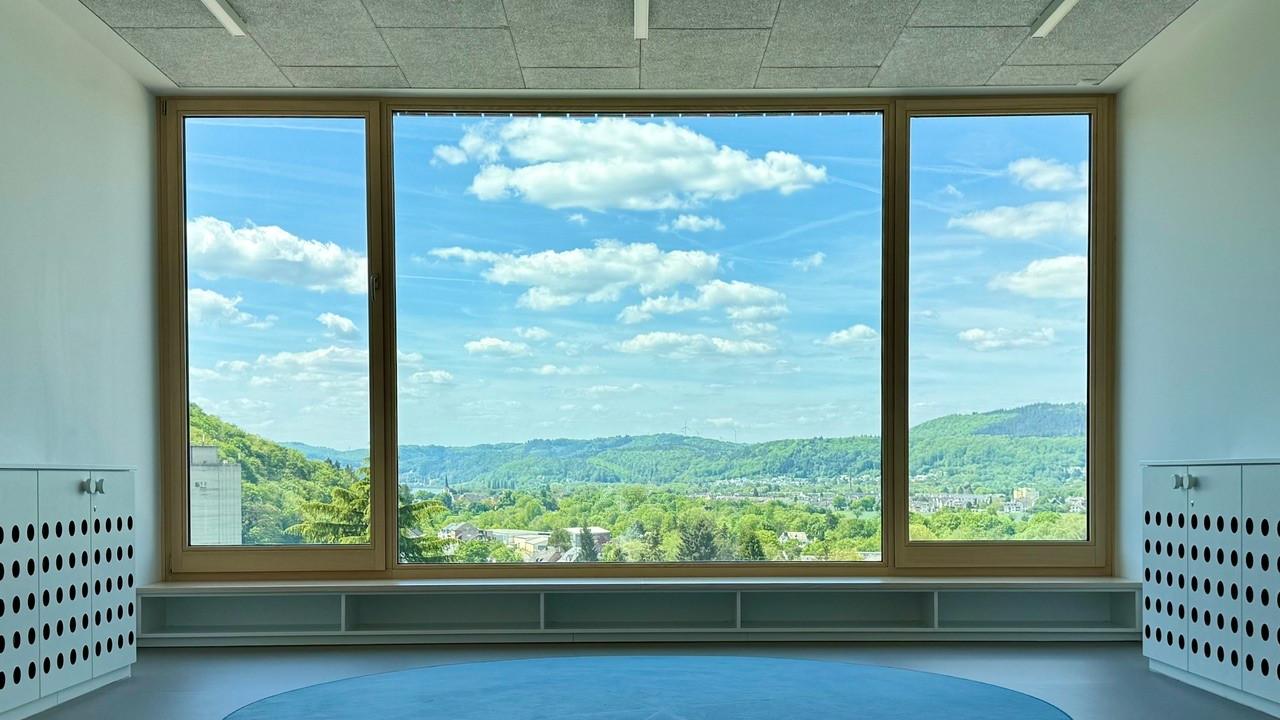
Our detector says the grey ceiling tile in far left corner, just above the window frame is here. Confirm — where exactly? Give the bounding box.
[118,27,289,87]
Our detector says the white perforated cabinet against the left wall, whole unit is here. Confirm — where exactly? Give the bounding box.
[0,469,137,716]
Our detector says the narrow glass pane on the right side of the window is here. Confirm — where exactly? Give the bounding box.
[908,115,1089,541]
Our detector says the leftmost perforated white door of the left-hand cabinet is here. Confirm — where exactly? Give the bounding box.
[0,470,40,715]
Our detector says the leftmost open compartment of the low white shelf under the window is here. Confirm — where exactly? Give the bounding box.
[142,593,342,637]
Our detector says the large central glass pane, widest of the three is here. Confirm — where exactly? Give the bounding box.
[394,114,882,562]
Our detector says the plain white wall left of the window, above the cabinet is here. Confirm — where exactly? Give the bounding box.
[0,0,160,583]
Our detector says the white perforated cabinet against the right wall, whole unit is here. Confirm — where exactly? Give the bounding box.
[1142,461,1280,715]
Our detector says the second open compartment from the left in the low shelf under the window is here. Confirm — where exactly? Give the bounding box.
[346,592,541,633]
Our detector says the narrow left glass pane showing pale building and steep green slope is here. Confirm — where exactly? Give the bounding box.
[184,118,370,546]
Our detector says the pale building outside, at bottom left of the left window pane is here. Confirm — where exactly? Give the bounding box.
[188,445,244,544]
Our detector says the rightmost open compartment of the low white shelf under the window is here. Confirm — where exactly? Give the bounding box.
[938,591,1138,632]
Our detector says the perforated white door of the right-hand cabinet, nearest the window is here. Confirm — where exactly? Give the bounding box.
[1142,468,1187,670]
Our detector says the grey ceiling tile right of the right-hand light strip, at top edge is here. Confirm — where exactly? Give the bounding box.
[1007,0,1196,65]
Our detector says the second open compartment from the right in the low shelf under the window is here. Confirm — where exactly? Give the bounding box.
[741,591,933,630]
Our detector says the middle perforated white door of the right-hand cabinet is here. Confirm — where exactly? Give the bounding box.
[1187,465,1244,688]
